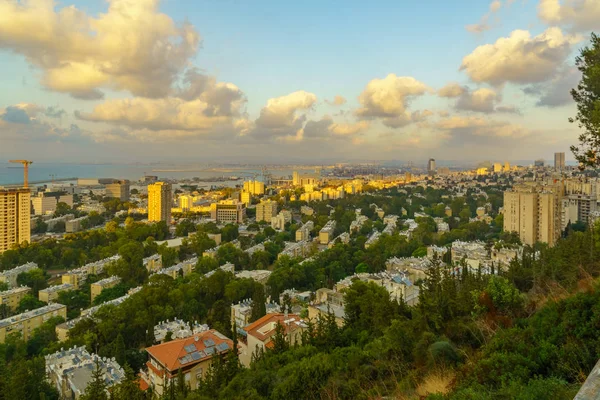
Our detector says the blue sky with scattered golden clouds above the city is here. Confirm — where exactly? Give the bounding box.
[0,0,600,164]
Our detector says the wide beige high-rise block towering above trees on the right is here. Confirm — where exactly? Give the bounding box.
[504,184,562,246]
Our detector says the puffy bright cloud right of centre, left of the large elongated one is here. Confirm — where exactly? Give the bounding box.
[354,74,432,128]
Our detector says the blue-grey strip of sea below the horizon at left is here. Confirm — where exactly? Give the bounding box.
[0,162,314,187]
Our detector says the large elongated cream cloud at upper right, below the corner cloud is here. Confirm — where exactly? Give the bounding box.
[460,28,580,85]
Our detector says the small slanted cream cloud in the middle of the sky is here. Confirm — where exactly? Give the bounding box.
[255,90,317,136]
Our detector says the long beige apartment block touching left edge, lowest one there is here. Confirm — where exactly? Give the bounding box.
[0,303,67,343]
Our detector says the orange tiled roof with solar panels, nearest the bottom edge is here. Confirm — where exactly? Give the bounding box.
[146,329,233,372]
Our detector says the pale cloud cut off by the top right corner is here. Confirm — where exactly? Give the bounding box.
[538,0,600,32]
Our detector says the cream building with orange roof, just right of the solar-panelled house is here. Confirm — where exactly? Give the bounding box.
[239,313,308,367]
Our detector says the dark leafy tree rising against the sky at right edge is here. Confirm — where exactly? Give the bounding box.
[569,33,600,167]
